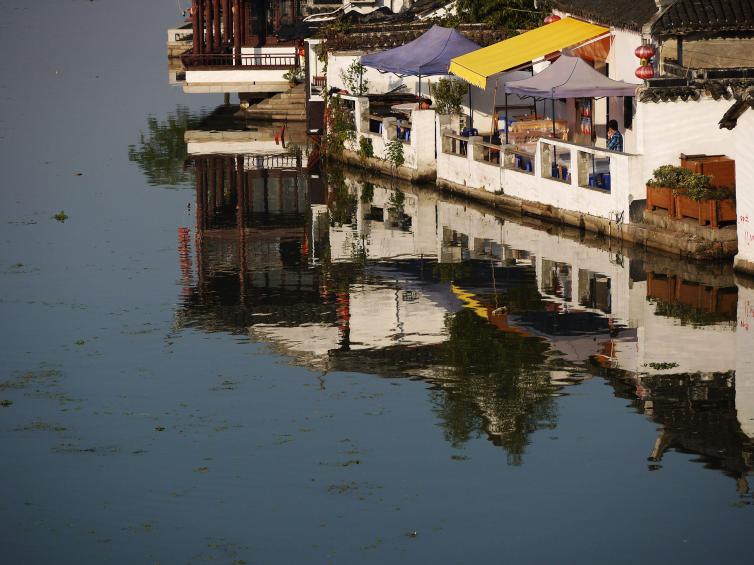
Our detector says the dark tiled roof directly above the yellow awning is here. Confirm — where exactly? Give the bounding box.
[553,0,657,31]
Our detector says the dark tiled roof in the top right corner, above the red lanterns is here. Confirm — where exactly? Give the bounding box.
[652,0,754,37]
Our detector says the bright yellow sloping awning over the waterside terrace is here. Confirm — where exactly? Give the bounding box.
[450,18,610,89]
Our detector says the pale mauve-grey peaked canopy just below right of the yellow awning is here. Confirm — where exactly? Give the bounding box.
[505,55,638,99]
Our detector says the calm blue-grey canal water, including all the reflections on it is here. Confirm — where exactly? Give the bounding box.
[0,0,754,565]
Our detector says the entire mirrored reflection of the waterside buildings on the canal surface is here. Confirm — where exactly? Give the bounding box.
[162,122,754,480]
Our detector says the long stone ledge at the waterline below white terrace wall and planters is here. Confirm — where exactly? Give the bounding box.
[437,180,738,261]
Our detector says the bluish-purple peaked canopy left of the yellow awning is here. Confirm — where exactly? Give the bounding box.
[361,25,479,76]
